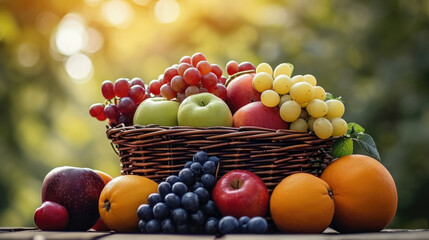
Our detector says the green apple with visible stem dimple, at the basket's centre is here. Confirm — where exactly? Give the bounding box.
[177,92,232,127]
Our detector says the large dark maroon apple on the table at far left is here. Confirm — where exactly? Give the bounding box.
[42,166,104,231]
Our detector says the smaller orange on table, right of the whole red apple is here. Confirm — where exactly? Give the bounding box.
[270,173,334,233]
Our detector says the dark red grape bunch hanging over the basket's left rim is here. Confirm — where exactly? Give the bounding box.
[89,78,150,126]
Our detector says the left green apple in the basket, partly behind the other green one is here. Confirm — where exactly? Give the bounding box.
[134,97,180,126]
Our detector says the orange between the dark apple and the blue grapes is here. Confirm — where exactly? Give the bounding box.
[98,175,158,232]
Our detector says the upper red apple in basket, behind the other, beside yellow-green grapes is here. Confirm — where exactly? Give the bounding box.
[226,74,261,113]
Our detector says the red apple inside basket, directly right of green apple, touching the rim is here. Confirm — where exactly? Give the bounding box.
[232,101,289,129]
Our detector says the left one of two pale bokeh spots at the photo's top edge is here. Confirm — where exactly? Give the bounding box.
[101,0,134,27]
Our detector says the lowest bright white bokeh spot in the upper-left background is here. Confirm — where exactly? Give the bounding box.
[64,53,93,83]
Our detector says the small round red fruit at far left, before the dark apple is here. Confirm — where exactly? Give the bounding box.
[34,201,69,231]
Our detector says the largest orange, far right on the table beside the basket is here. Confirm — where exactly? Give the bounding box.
[321,154,398,232]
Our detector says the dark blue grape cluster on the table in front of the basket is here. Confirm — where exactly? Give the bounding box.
[137,151,267,235]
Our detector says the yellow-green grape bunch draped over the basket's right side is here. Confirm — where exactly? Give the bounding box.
[252,63,347,139]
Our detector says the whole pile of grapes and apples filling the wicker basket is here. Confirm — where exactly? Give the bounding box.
[89,53,347,139]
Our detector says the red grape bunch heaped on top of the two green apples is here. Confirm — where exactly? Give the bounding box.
[149,53,226,102]
